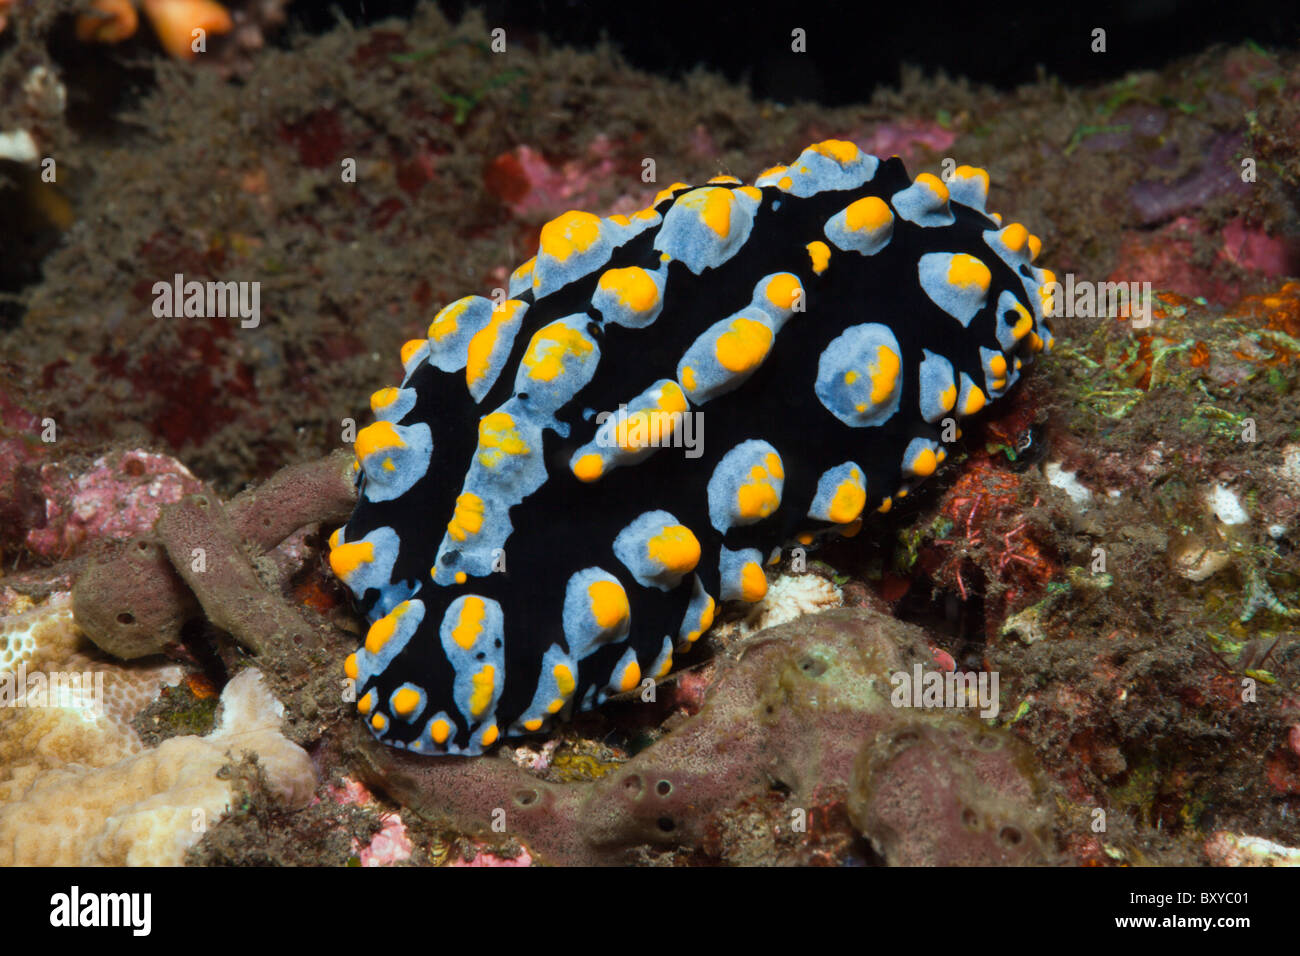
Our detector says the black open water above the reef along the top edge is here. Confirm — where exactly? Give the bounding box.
[299,0,1300,105]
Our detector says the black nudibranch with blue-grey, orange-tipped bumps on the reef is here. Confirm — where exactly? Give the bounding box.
[329,140,1054,754]
